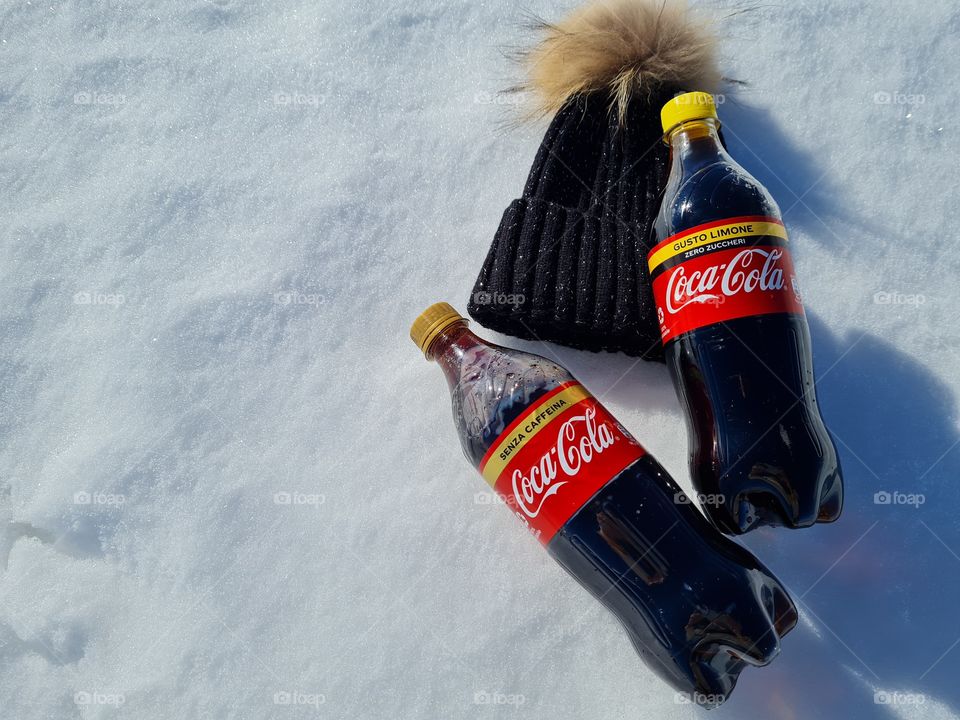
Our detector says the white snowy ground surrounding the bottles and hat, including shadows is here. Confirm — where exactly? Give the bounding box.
[0,0,960,719]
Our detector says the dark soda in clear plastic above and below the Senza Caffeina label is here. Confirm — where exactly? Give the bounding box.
[428,322,797,706]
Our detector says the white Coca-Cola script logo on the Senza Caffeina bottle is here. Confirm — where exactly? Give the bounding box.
[511,407,616,518]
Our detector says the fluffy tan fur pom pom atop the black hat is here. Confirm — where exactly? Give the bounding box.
[517,0,721,122]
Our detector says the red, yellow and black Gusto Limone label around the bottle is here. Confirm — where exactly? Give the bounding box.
[647,215,803,344]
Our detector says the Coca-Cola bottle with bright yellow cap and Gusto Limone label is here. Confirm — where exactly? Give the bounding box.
[647,92,843,533]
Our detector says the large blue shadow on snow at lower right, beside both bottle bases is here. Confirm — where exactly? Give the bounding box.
[711,316,960,718]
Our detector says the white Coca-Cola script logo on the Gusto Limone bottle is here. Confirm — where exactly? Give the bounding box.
[666,248,784,315]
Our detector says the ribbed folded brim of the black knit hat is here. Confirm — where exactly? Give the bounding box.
[468,197,662,359]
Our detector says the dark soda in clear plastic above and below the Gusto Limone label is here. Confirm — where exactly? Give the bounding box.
[654,120,843,533]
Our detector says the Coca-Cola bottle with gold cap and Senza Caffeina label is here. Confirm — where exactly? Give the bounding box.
[410,303,797,705]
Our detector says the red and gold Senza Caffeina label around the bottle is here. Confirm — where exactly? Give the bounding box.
[480,382,646,545]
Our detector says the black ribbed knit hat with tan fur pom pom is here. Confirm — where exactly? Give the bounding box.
[467,0,720,360]
